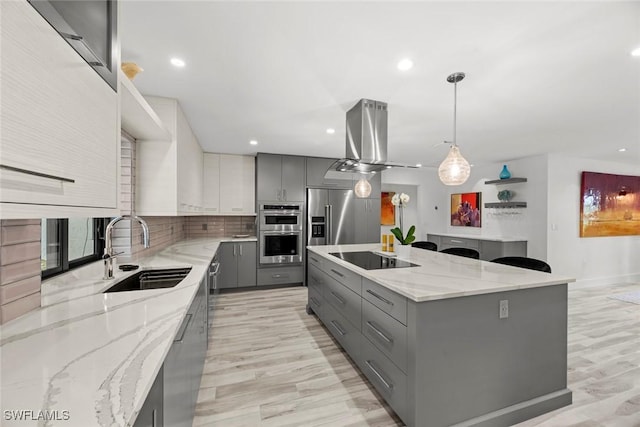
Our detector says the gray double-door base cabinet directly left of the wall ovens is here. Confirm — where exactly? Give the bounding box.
[218,242,257,289]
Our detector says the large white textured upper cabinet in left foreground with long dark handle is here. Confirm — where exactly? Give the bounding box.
[0,1,120,218]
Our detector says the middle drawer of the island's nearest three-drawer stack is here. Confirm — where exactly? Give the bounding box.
[362,300,407,373]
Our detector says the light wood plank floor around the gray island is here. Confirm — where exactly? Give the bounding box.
[193,283,640,427]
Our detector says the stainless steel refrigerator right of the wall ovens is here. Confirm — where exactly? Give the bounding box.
[307,188,357,246]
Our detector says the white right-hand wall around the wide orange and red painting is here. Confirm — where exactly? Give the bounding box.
[547,155,640,284]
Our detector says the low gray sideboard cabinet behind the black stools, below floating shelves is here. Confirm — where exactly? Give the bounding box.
[427,233,527,261]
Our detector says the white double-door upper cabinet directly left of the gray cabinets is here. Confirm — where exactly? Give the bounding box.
[203,153,256,215]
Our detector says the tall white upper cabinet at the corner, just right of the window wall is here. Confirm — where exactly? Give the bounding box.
[136,96,203,216]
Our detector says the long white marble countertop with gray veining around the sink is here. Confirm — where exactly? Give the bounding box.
[0,237,235,427]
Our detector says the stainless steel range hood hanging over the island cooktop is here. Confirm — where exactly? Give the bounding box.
[327,99,415,175]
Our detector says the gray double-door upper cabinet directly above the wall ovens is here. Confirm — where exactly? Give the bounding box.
[256,153,305,202]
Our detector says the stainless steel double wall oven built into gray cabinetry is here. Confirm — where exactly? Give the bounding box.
[258,203,304,265]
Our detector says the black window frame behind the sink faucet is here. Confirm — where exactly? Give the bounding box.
[40,218,110,279]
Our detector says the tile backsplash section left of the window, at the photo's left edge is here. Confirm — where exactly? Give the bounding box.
[0,219,40,324]
